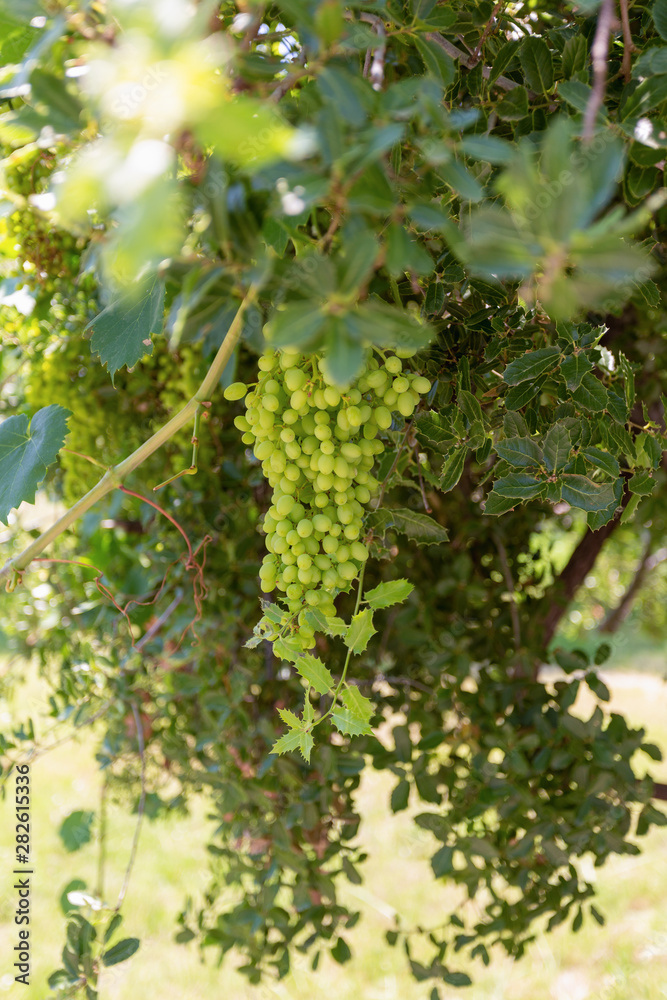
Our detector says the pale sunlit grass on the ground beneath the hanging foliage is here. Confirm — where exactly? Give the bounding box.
[0,674,667,1000]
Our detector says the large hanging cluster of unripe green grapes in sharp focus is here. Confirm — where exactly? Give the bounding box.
[225,350,431,614]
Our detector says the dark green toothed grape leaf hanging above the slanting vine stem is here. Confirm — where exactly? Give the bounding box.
[86,277,164,383]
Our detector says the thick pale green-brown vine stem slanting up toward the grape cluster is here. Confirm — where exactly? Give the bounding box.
[0,285,258,580]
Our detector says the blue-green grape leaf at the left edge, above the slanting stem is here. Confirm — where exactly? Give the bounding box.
[0,403,72,524]
